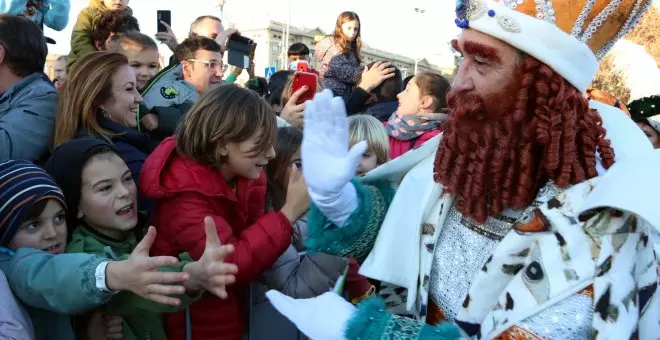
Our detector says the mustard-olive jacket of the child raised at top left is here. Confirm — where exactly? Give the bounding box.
[66,0,133,72]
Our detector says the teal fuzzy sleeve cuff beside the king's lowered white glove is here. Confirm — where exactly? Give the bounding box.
[344,298,461,340]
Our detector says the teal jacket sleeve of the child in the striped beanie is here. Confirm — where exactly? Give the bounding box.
[0,248,113,340]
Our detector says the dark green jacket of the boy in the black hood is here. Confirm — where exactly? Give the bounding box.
[66,224,196,340]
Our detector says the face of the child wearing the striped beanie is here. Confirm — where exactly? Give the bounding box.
[9,199,66,254]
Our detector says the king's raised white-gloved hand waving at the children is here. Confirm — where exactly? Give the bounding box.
[301,90,367,196]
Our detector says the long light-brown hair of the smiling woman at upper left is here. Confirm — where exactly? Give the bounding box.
[53,52,128,148]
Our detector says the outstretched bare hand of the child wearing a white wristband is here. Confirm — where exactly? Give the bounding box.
[106,227,189,306]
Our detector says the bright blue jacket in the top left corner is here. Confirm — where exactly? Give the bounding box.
[0,0,71,31]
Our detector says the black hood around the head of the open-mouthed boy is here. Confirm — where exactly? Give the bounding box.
[44,138,121,231]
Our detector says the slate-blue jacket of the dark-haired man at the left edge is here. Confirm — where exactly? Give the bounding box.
[0,73,57,162]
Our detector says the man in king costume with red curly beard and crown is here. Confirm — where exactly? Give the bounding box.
[268,0,660,340]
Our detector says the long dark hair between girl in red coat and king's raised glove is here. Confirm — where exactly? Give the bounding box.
[266,126,302,210]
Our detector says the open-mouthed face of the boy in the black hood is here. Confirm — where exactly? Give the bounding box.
[78,153,138,240]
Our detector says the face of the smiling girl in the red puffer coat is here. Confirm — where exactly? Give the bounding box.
[220,130,275,179]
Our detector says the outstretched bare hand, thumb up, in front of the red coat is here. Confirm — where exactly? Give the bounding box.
[184,216,238,299]
